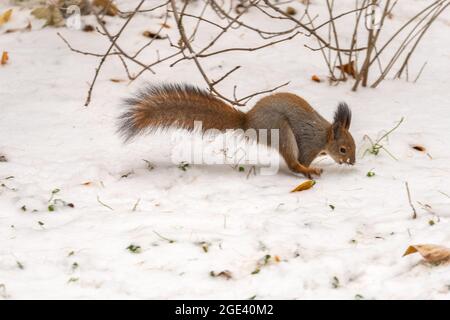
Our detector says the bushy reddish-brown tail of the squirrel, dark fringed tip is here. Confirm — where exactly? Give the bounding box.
[118,84,245,141]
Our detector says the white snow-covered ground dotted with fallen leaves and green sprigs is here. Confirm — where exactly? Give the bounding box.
[0,0,450,299]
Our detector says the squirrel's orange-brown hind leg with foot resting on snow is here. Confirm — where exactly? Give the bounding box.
[279,121,322,179]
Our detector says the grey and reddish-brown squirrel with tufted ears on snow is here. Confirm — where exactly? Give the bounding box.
[118,84,355,179]
